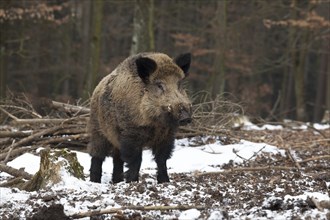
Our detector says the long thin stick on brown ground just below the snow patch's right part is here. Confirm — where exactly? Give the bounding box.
[197,166,297,176]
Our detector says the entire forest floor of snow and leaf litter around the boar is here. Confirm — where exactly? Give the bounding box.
[0,123,330,219]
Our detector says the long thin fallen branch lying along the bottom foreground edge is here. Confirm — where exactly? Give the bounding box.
[69,205,205,219]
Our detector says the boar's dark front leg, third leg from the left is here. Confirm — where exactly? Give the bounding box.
[120,138,142,183]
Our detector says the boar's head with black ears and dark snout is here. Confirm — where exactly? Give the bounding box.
[135,53,192,125]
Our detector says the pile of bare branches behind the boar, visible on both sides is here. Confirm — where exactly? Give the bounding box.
[0,94,242,163]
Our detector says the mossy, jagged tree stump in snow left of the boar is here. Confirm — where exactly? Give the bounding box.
[22,149,85,191]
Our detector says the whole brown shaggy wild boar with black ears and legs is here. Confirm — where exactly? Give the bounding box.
[88,53,192,183]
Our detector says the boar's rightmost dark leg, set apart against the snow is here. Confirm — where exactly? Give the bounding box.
[153,140,174,183]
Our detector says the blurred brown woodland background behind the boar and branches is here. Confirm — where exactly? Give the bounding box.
[0,0,330,122]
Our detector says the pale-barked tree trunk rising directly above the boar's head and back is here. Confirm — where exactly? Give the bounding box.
[130,0,155,54]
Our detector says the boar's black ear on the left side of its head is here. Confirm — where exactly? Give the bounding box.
[135,57,157,83]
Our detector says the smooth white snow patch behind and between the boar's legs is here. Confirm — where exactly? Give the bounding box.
[71,138,285,179]
